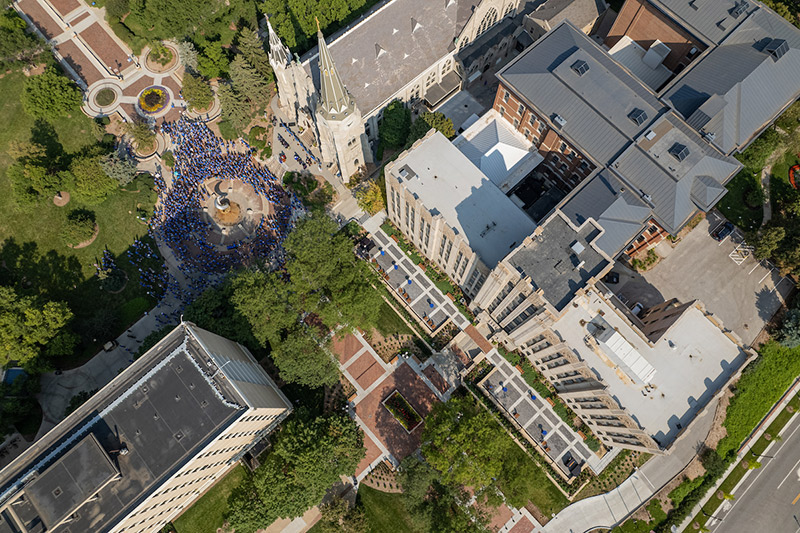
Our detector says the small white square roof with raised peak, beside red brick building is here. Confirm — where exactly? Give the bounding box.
[453,109,544,194]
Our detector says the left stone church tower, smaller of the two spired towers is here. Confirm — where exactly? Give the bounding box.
[267,18,317,124]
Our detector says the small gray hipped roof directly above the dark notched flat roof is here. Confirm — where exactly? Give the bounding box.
[561,170,651,257]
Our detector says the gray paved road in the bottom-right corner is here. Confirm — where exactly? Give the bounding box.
[706,410,800,533]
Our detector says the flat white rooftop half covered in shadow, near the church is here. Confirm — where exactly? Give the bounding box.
[390,131,536,268]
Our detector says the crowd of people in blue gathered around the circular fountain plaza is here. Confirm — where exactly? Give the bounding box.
[150,117,296,274]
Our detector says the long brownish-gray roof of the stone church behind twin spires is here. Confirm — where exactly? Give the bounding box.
[303,0,480,115]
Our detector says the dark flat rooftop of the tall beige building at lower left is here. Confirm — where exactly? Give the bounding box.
[0,323,288,533]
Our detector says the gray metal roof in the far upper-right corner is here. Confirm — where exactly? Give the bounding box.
[665,9,800,153]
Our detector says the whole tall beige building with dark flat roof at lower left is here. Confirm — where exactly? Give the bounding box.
[0,323,292,533]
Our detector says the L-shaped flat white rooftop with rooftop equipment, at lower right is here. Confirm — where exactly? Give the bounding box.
[553,290,746,447]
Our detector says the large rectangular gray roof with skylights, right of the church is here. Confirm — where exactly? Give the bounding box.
[498,23,666,164]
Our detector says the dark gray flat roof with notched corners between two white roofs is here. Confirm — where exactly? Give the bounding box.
[508,211,611,311]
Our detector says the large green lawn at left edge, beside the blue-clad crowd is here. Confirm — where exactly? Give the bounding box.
[0,68,160,367]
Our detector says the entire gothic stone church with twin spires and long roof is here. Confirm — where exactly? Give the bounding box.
[268,0,526,181]
